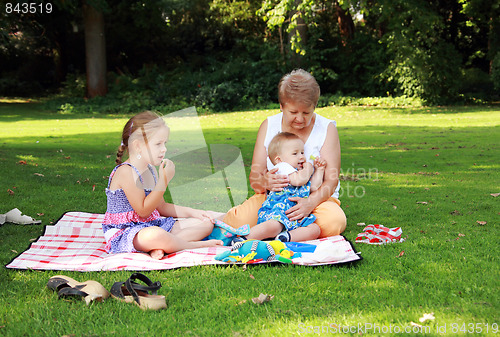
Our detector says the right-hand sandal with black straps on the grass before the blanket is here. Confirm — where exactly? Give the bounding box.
[111,273,167,310]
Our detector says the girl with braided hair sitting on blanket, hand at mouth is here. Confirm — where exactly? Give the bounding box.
[102,111,222,259]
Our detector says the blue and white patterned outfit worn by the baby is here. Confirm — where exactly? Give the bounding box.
[257,162,316,231]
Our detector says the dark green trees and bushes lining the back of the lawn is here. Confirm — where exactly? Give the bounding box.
[0,0,500,105]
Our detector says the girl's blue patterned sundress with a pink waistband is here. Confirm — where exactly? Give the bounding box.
[102,163,175,253]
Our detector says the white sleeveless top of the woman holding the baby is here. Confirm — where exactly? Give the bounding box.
[264,112,340,199]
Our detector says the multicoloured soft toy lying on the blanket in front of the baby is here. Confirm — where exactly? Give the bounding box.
[215,240,301,264]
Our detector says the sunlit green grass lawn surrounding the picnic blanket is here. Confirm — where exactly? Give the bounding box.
[0,103,500,336]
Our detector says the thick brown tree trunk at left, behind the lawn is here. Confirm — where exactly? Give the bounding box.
[83,2,108,98]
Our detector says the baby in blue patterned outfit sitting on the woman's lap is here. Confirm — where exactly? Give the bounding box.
[237,132,326,242]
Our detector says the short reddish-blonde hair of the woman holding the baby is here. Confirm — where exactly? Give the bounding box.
[278,69,321,107]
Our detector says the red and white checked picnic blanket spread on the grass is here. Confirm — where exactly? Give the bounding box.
[6,212,361,271]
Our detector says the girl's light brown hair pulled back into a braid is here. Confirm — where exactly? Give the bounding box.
[116,111,166,165]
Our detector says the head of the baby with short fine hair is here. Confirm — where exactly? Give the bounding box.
[267,132,306,169]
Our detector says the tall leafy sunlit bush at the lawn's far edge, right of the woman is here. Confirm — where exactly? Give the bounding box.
[385,0,461,104]
